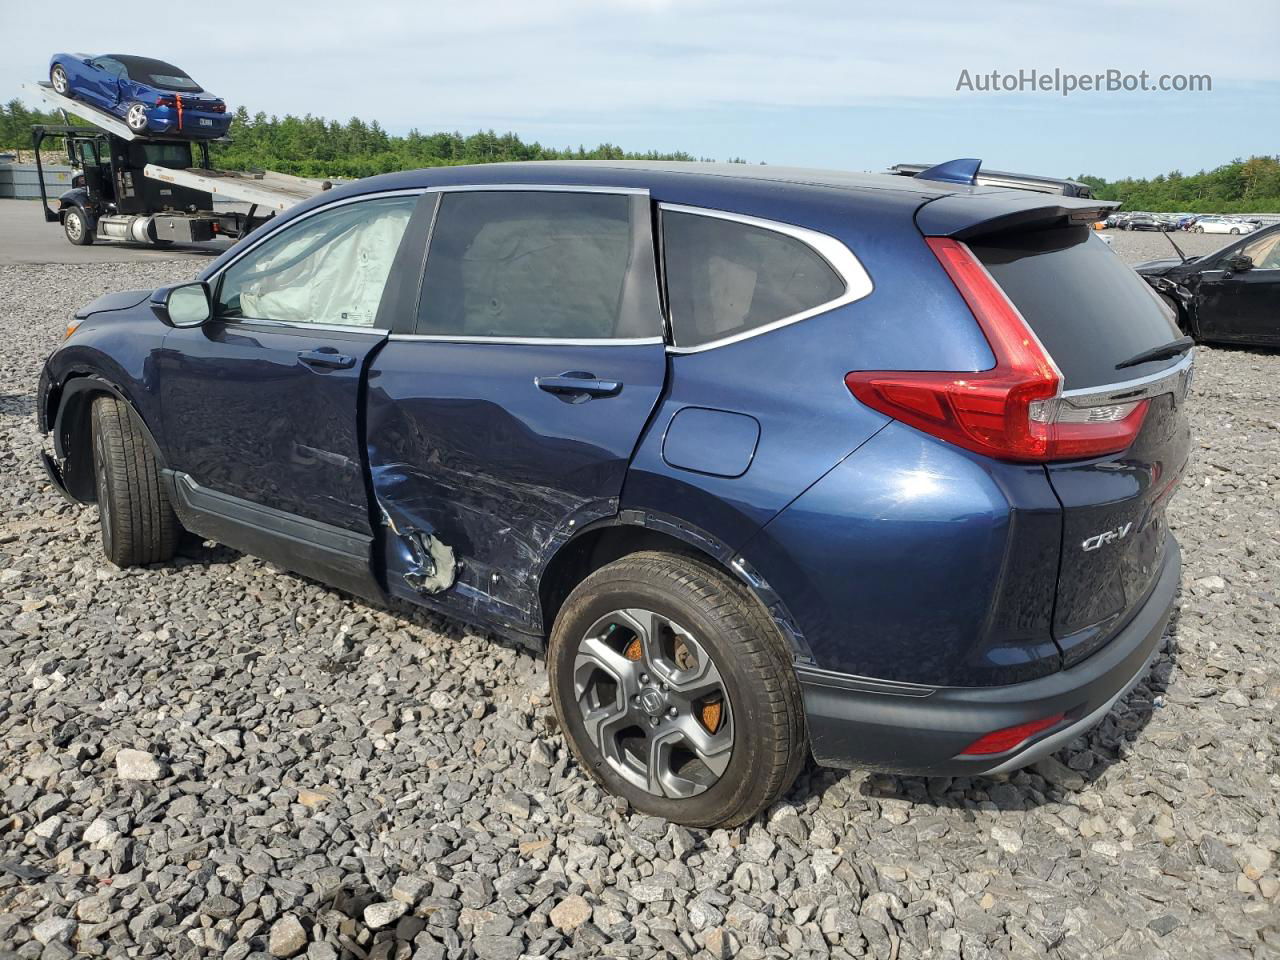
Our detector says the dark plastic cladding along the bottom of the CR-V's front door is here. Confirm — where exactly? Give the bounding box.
[164,470,387,604]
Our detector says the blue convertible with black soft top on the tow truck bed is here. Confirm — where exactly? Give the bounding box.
[49,54,232,138]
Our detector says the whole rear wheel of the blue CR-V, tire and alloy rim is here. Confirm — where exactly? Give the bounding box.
[547,553,808,827]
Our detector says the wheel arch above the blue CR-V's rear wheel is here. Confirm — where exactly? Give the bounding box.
[538,509,813,663]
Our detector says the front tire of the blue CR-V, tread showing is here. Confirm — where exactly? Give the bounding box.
[92,397,182,567]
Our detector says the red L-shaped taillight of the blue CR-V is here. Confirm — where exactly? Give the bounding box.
[845,237,1147,462]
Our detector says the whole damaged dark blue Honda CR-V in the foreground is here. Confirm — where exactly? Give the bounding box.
[38,163,1192,824]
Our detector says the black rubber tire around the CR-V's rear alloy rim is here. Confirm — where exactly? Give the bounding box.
[547,552,809,827]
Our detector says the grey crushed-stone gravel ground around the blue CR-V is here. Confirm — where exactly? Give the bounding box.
[0,259,1280,960]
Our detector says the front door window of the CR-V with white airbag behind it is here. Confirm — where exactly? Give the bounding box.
[216,196,417,326]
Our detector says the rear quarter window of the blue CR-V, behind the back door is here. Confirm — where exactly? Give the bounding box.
[662,210,845,347]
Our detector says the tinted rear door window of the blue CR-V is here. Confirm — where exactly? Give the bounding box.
[417,191,631,339]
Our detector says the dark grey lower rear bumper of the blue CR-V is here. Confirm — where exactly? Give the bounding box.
[797,536,1181,777]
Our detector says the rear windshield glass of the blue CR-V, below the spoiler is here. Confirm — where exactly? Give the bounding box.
[969,227,1181,390]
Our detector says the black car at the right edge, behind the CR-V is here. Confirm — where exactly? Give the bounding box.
[1134,224,1280,347]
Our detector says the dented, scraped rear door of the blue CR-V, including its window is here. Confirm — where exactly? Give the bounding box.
[366,188,666,632]
